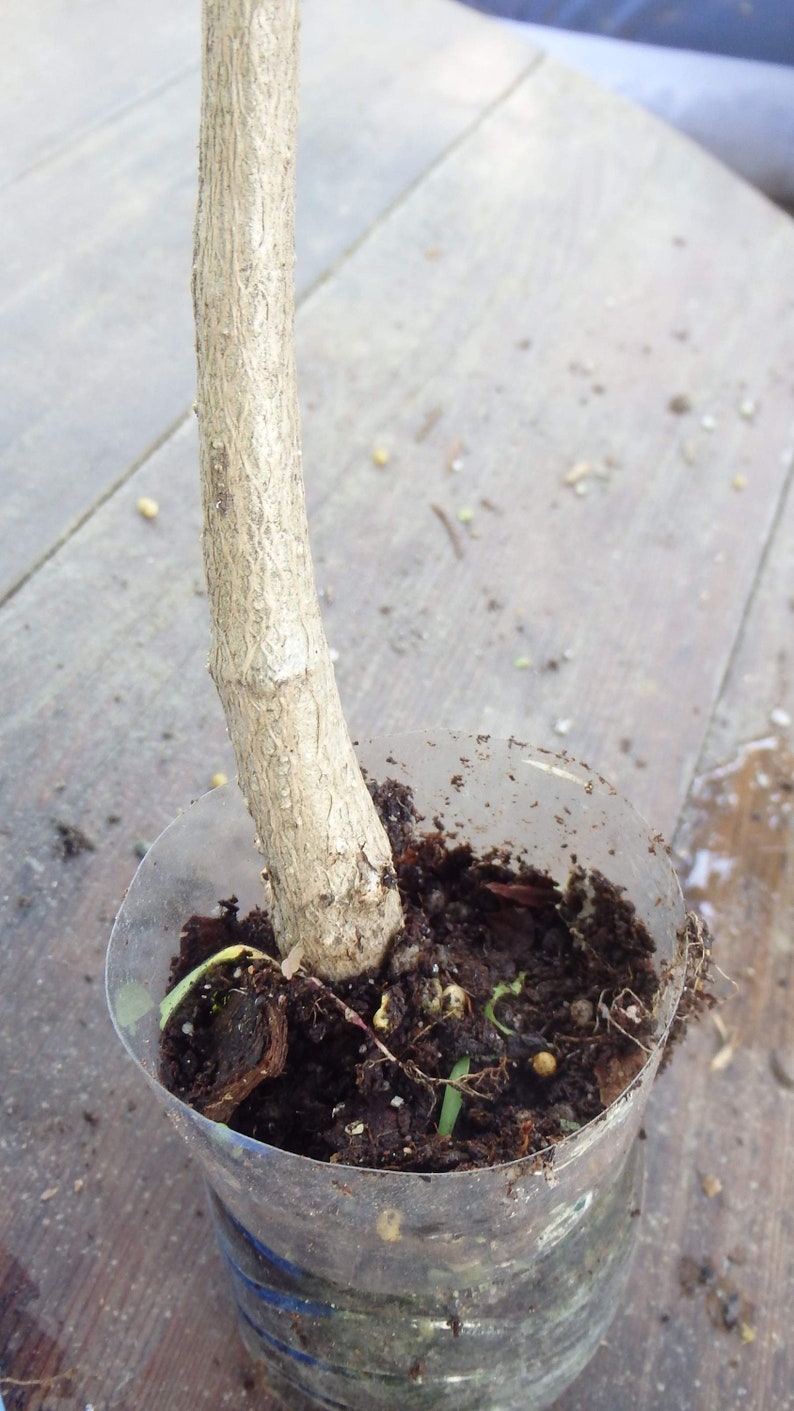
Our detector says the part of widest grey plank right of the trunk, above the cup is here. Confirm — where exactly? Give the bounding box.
[300,63,794,831]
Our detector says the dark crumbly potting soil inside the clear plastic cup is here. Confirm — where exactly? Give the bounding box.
[161,783,671,1171]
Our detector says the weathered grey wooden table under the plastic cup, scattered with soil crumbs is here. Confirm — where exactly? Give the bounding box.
[0,0,794,1411]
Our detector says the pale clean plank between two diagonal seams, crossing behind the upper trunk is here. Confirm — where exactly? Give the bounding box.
[0,0,533,593]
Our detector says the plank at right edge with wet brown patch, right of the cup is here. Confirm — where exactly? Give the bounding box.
[560,476,794,1411]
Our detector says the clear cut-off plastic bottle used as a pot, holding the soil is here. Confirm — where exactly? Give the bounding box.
[107,734,685,1411]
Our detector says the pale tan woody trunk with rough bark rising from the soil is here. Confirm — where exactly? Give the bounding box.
[193,0,402,979]
